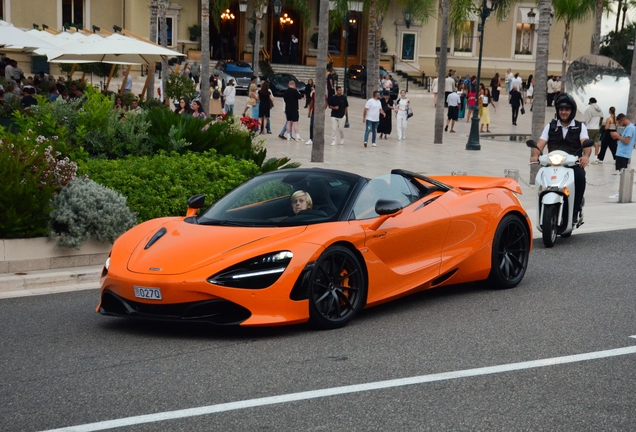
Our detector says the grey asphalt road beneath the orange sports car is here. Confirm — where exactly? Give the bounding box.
[0,230,636,431]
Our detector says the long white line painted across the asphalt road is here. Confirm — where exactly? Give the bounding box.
[43,335,636,432]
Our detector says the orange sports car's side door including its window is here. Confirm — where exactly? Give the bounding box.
[353,174,450,304]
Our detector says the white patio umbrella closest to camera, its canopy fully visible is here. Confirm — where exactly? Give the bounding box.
[50,34,185,65]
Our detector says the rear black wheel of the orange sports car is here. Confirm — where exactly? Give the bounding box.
[488,215,530,289]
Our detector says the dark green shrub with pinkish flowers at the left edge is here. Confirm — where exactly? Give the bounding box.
[0,136,77,239]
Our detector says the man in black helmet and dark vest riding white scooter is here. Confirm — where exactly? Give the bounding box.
[530,93,592,221]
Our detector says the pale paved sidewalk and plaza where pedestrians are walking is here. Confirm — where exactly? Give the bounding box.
[0,86,636,299]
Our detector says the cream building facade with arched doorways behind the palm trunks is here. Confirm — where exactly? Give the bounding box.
[0,0,594,78]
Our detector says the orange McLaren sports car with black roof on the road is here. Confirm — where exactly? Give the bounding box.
[97,168,532,328]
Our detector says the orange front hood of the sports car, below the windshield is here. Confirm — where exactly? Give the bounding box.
[128,220,307,275]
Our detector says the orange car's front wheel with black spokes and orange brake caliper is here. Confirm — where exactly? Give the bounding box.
[309,246,367,329]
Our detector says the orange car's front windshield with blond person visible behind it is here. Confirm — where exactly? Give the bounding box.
[197,170,358,227]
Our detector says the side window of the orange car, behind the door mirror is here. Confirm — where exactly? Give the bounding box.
[352,174,423,219]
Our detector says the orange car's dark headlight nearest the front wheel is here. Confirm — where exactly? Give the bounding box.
[207,251,294,289]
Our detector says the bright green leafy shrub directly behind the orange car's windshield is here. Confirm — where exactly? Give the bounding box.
[82,151,258,222]
